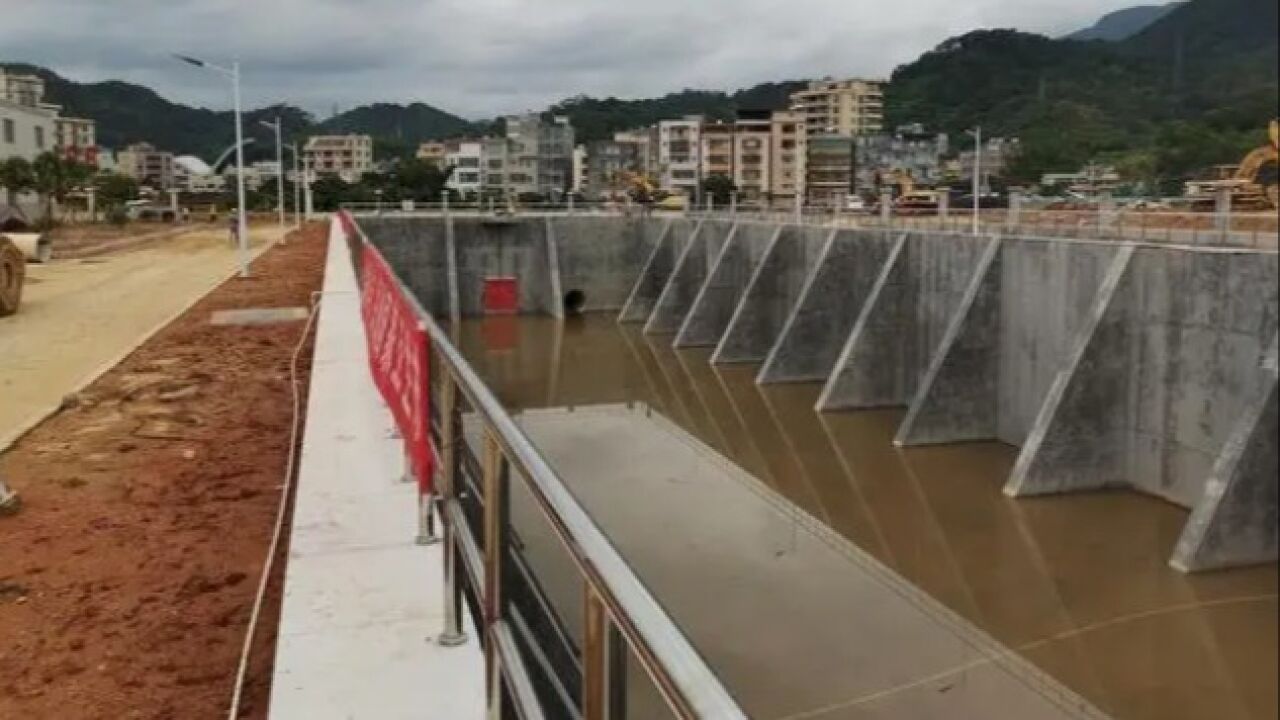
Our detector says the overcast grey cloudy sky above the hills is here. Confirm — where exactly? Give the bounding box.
[0,0,1139,118]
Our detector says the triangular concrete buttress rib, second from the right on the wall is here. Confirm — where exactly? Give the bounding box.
[1005,245,1134,497]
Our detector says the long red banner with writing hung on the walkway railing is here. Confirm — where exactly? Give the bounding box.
[360,240,434,493]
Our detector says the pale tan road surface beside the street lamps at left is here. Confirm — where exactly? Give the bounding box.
[0,227,290,451]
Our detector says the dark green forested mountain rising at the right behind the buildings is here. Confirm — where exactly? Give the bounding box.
[886,0,1280,186]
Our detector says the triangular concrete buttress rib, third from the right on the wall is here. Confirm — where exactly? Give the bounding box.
[893,237,1001,446]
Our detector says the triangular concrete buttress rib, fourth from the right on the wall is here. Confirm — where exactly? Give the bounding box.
[815,233,908,411]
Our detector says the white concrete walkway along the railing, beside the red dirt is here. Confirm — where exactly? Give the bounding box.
[270,221,484,720]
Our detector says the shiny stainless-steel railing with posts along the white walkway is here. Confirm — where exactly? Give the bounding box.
[348,219,746,720]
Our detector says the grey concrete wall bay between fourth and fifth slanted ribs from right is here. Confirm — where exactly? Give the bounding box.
[755,231,892,384]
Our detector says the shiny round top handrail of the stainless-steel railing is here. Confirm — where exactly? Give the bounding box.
[356,215,746,719]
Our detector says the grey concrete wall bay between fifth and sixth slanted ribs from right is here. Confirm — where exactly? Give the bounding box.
[712,225,835,363]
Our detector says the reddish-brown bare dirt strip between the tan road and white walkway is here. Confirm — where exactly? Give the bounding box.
[0,225,325,720]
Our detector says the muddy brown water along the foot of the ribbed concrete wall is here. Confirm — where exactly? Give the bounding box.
[460,315,1277,720]
